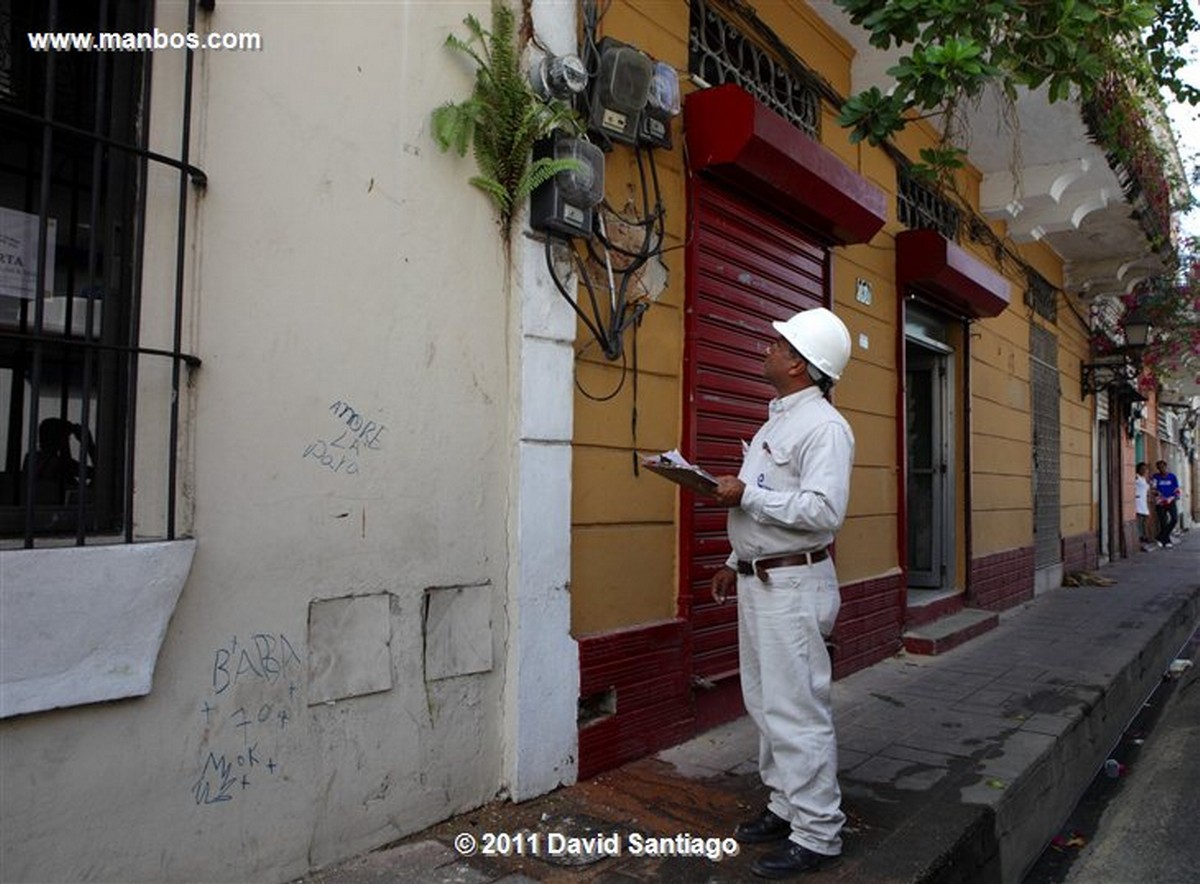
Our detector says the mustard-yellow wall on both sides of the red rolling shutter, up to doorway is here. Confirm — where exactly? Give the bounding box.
[571,0,898,636]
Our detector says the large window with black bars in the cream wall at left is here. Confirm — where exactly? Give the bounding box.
[0,0,204,547]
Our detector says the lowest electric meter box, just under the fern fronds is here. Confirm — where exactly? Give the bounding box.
[529,137,604,236]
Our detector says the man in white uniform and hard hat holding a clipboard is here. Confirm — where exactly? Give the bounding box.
[713,307,854,878]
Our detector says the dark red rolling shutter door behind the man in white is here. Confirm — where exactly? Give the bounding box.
[679,178,829,723]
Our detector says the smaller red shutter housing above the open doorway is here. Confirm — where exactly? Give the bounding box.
[896,230,1009,319]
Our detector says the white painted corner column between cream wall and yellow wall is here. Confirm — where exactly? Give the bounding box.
[504,0,580,801]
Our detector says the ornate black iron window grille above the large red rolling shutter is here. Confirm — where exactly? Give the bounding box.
[688,0,821,138]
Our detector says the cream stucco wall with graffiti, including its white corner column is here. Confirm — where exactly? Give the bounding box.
[0,2,577,882]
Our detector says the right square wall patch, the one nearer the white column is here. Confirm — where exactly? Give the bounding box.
[425,584,492,681]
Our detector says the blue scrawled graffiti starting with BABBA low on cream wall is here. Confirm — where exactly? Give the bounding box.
[191,632,304,805]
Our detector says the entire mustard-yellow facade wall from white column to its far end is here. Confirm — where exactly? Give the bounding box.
[571,0,1092,636]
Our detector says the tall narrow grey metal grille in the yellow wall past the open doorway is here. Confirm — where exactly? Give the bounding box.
[1030,325,1062,567]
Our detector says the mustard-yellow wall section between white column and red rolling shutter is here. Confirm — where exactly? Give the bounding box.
[571,0,688,636]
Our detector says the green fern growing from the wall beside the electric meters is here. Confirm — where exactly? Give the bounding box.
[433,0,580,239]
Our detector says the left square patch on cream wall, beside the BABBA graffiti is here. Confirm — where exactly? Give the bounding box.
[308,594,391,705]
